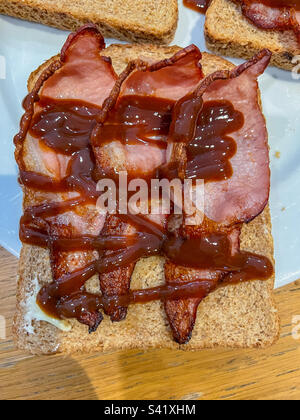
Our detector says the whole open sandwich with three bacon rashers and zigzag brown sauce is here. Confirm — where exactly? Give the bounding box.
[14,25,279,354]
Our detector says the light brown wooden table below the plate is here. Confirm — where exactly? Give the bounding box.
[0,248,300,400]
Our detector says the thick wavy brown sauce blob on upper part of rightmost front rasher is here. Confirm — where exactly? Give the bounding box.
[169,94,244,182]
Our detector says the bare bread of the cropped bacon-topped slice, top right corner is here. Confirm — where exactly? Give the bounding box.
[205,0,300,70]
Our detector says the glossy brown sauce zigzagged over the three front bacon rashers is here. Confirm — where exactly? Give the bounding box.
[16,80,273,319]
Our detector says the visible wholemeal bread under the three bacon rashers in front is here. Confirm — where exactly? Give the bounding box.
[14,45,279,354]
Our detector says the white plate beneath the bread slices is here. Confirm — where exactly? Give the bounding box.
[0,1,300,287]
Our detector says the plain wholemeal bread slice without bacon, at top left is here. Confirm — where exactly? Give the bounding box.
[0,0,178,44]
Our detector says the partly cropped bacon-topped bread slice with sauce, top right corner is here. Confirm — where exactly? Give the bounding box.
[205,0,300,71]
